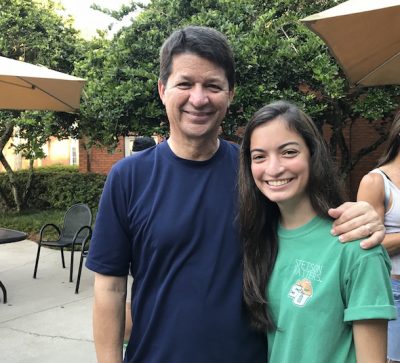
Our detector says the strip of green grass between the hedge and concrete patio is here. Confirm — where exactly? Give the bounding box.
[0,209,65,241]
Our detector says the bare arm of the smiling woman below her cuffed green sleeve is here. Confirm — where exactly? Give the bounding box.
[353,319,387,363]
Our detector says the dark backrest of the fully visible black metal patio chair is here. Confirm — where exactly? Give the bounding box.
[61,203,92,244]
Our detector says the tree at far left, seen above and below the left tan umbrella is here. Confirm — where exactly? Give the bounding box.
[0,0,84,210]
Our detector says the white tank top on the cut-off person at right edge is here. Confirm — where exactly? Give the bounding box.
[370,169,400,275]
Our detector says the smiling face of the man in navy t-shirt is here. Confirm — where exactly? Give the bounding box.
[158,53,233,141]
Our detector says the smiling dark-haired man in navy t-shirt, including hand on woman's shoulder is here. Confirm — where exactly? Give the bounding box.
[86,26,383,363]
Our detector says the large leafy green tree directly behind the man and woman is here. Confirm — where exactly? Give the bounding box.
[76,0,400,178]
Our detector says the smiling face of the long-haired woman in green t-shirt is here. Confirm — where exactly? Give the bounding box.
[250,117,310,212]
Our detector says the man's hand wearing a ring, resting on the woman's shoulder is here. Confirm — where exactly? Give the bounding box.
[328,201,385,249]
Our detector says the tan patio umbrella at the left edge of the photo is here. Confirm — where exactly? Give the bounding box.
[0,57,85,112]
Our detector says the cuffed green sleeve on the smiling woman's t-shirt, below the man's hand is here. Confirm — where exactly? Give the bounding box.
[344,246,396,322]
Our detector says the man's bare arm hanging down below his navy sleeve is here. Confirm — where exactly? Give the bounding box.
[93,273,127,363]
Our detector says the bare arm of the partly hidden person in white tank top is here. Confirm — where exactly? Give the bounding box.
[357,174,400,255]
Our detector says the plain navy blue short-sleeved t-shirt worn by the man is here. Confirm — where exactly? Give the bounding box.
[86,140,266,363]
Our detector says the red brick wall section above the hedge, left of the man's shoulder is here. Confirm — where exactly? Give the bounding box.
[79,137,125,174]
